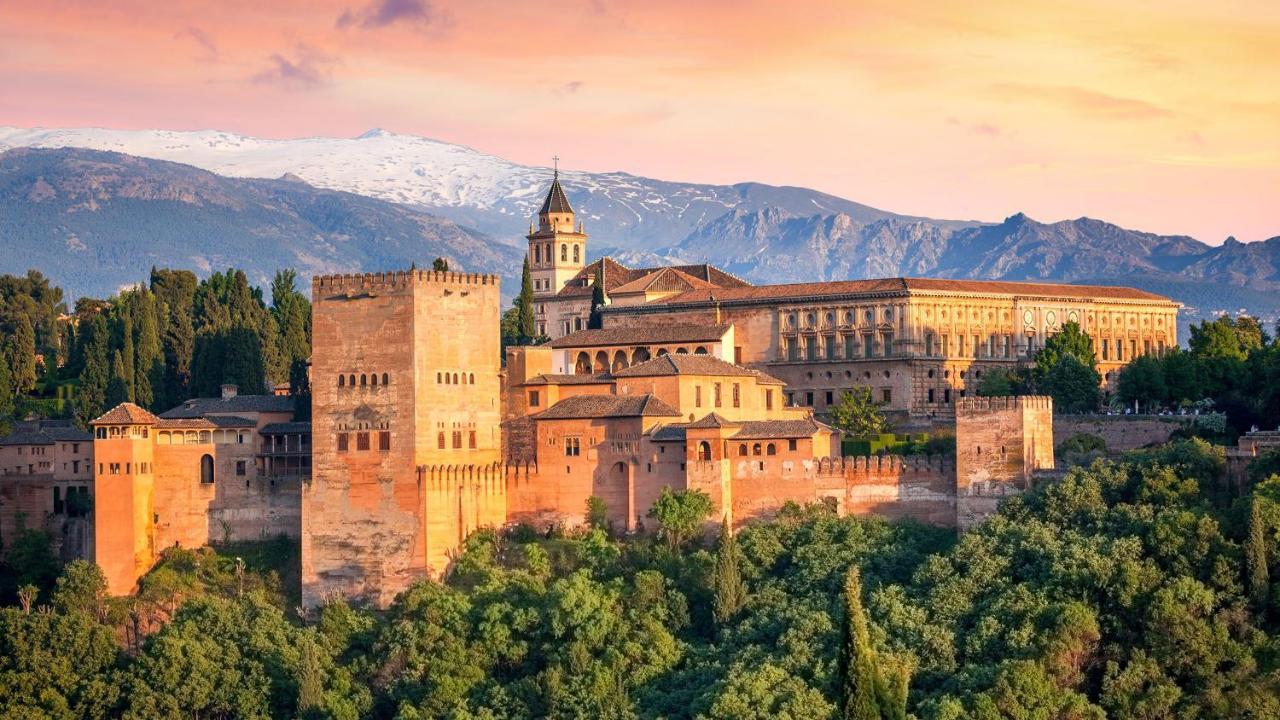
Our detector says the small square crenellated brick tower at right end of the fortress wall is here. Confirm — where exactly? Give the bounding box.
[956,395,1053,530]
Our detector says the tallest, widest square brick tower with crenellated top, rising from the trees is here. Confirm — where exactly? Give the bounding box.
[302,270,503,607]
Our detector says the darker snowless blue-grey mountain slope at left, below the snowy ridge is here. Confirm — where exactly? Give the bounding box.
[0,149,522,297]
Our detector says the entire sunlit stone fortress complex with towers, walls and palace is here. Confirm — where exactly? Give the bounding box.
[0,170,1178,607]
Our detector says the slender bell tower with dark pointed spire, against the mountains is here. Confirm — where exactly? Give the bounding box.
[527,158,586,324]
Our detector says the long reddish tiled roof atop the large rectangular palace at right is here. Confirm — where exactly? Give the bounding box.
[654,272,1172,305]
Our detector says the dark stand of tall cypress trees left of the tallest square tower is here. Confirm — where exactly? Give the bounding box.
[0,268,311,430]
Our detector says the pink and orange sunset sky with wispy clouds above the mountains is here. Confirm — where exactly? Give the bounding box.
[0,0,1280,245]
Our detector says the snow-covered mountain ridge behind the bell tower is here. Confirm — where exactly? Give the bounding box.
[0,128,975,252]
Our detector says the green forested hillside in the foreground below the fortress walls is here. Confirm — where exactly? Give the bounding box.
[0,439,1280,720]
